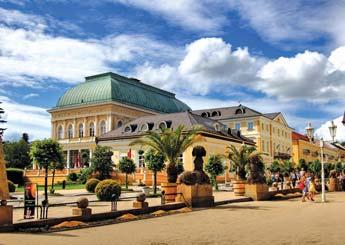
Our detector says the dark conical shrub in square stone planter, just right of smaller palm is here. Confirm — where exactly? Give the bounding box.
[245,154,269,201]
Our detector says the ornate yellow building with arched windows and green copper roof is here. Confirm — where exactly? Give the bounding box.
[48,73,190,169]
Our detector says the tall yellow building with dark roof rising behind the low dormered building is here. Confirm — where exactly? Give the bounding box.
[193,105,293,164]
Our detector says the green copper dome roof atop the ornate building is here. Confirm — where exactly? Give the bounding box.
[54,72,190,113]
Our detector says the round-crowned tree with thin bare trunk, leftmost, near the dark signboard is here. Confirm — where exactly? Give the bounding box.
[30,139,63,206]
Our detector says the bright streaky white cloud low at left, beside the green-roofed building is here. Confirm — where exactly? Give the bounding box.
[0,96,50,140]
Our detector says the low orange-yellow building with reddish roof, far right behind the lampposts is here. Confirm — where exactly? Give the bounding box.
[292,132,345,164]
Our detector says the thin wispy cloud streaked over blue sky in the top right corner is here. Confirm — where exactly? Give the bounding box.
[228,0,345,47]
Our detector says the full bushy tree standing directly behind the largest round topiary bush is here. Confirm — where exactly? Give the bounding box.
[90,145,113,180]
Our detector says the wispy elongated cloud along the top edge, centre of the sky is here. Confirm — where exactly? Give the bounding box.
[107,0,226,32]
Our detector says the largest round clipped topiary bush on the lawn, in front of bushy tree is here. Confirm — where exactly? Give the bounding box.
[95,179,121,201]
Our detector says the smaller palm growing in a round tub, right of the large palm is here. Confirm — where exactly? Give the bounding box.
[228,145,255,196]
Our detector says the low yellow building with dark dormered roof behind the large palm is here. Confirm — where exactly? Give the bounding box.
[98,111,255,174]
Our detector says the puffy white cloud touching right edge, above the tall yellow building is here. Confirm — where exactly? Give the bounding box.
[257,47,345,101]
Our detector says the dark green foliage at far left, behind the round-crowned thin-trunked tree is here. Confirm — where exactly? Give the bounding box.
[4,139,31,169]
